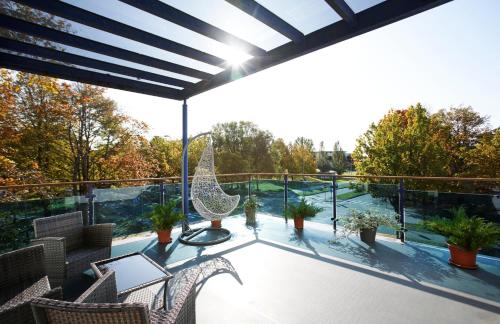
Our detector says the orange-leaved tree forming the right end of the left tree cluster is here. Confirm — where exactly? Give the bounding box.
[66,84,151,181]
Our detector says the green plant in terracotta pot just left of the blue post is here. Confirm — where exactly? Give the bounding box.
[149,200,188,244]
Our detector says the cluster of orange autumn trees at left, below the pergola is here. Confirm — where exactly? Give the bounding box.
[0,70,152,189]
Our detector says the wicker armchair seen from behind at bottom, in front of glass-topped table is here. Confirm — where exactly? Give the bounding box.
[31,270,200,324]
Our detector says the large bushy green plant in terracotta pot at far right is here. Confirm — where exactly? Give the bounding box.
[424,207,500,269]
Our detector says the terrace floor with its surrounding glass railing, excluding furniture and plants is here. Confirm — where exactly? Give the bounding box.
[0,174,500,323]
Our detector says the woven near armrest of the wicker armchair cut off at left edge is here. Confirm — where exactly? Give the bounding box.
[0,276,50,311]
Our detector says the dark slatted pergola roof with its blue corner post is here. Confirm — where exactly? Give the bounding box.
[0,0,450,218]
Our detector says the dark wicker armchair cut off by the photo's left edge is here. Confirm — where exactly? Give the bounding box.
[0,245,62,324]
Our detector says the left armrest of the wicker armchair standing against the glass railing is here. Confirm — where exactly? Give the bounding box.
[31,237,66,287]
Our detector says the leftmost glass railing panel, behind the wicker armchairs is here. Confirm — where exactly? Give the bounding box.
[0,187,88,253]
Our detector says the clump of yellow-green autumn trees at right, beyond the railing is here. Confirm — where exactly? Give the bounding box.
[353,104,500,177]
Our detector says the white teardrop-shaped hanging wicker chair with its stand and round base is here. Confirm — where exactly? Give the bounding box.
[179,132,236,246]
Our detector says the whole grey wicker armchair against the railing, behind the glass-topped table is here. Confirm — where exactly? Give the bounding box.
[32,211,114,286]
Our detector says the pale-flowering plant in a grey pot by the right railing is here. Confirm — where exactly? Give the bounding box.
[342,209,398,244]
